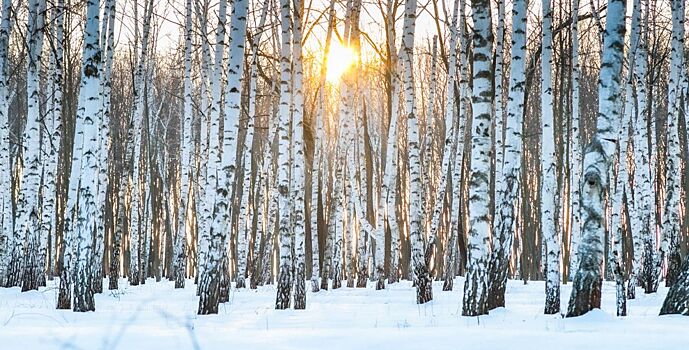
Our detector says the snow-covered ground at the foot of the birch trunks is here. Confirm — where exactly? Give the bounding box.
[0,278,689,350]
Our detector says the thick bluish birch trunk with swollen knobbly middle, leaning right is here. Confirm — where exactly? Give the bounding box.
[567,0,626,317]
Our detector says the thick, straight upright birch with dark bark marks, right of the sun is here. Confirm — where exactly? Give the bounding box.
[462,0,494,316]
